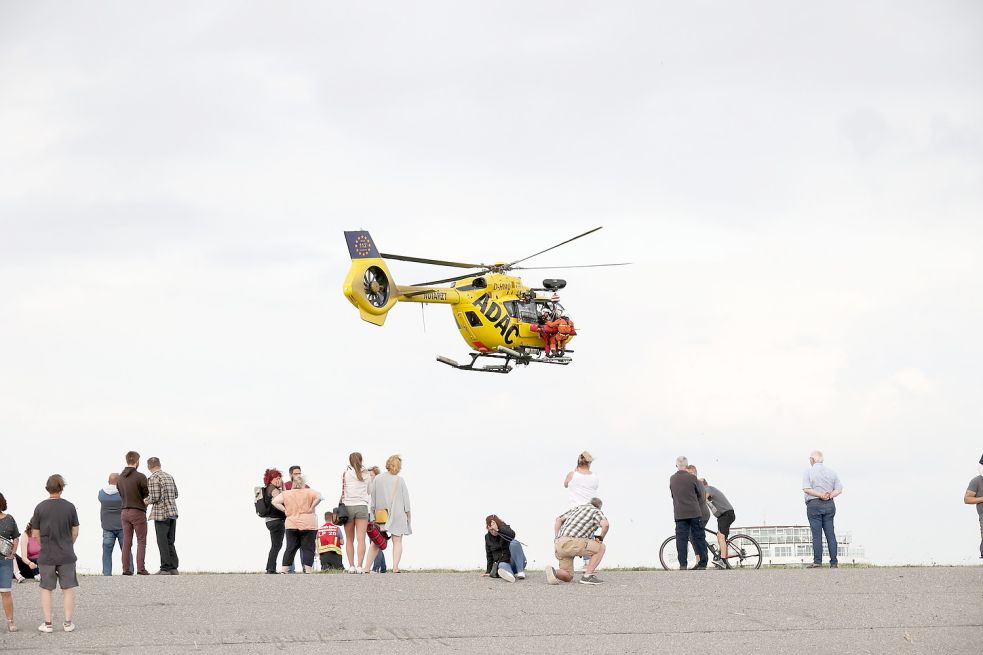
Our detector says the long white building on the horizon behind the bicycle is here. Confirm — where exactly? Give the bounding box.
[730,525,867,566]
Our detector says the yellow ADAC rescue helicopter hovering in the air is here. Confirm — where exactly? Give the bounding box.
[343,227,630,373]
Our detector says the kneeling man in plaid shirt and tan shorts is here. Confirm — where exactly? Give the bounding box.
[546,498,609,584]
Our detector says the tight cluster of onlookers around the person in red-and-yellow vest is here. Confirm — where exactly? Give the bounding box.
[256,452,413,574]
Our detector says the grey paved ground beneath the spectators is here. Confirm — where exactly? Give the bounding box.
[0,567,983,655]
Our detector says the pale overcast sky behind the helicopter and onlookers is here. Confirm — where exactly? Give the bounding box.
[0,1,983,570]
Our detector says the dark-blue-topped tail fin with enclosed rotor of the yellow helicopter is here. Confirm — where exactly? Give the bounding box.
[342,231,399,325]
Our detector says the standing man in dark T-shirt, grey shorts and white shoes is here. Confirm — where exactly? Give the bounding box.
[31,474,78,632]
